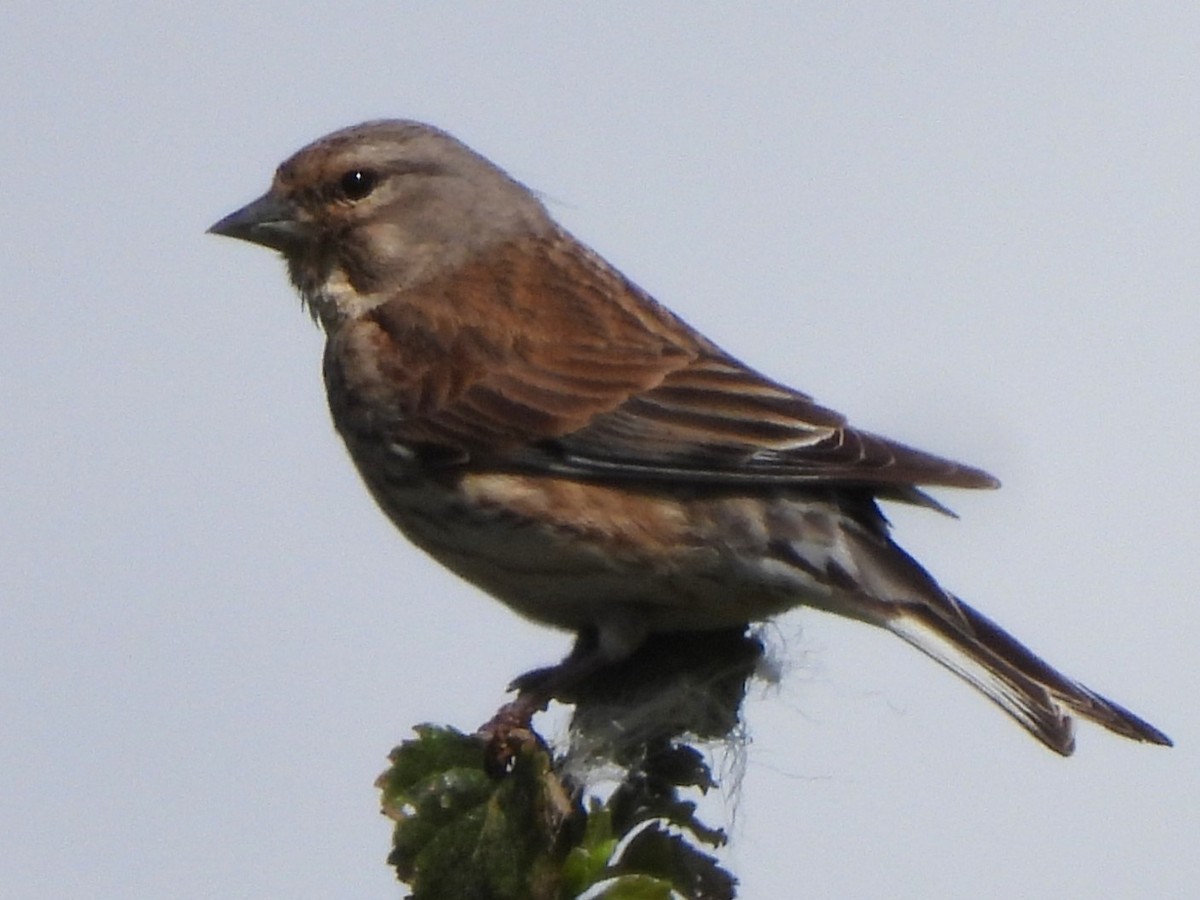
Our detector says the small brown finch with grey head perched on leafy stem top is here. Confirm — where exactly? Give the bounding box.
[209,120,1171,756]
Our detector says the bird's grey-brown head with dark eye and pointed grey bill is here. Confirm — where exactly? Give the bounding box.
[209,120,553,325]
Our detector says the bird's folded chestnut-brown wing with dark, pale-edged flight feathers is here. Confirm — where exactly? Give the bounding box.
[360,241,996,488]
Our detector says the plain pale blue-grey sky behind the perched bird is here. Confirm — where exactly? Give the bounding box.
[0,2,1200,898]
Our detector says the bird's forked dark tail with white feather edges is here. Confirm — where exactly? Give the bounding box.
[881,599,1171,756]
